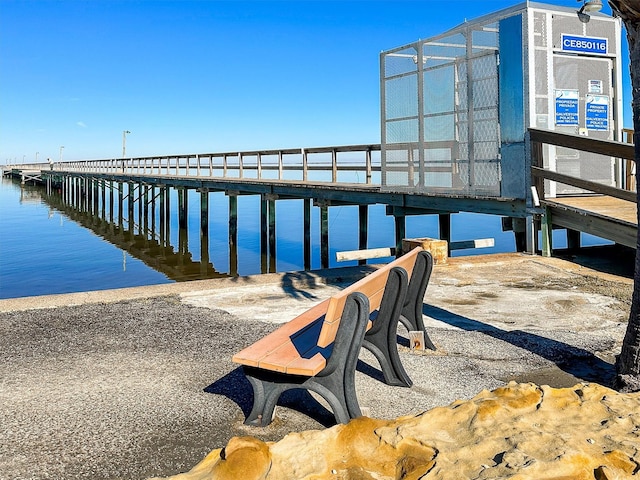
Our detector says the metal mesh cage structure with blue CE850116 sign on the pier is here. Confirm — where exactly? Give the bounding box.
[380,2,622,203]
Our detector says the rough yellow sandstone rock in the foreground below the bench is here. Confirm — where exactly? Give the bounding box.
[154,382,640,480]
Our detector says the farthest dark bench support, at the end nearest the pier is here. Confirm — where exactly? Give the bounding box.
[400,250,437,350]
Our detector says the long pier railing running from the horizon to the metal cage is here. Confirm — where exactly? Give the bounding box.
[13,144,381,184]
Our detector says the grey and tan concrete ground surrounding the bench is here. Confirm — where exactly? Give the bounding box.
[0,254,632,480]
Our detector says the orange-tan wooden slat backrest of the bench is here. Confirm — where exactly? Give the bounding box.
[318,247,422,348]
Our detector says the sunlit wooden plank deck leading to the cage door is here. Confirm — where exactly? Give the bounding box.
[541,195,638,248]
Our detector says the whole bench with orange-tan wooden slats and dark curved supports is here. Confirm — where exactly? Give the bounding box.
[233,248,433,426]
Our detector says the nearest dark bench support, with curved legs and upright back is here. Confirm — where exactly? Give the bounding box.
[243,292,369,427]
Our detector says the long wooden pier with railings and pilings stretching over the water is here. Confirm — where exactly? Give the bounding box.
[3,129,637,275]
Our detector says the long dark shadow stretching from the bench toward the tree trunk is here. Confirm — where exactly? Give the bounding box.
[422,304,615,387]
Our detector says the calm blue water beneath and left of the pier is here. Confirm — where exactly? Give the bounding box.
[0,174,602,298]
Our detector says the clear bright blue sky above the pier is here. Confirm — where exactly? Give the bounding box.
[0,0,631,163]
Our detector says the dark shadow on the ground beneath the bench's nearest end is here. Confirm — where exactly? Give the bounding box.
[204,367,336,428]
